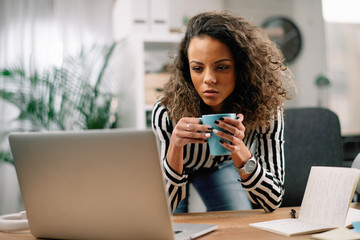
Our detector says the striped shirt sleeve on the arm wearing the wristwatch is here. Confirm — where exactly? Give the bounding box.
[242,111,285,212]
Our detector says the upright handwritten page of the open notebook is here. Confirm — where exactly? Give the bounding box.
[299,167,359,227]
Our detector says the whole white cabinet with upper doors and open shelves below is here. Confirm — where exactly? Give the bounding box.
[112,0,180,129]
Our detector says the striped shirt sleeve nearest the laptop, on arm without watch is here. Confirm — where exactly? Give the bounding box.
[152,101,188,211]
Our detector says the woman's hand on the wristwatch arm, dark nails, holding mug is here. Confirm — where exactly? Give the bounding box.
[213,114,251,167]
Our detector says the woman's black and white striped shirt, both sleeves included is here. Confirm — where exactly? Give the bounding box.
[152,101,285,212]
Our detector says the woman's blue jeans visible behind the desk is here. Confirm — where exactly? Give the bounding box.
[175,161,252,213]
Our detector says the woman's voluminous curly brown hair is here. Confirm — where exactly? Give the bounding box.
[161,11,294,130]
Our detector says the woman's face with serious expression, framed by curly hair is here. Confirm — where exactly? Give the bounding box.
[188,36,236,113]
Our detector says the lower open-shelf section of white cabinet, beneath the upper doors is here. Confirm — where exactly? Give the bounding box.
[119,34,181,129]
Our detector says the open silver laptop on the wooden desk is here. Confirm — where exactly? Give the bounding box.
[9,129,217,240]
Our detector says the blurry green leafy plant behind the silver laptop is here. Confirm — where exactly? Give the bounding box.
[0,43,119,163]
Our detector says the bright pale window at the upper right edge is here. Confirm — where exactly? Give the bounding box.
[322,0,360,135]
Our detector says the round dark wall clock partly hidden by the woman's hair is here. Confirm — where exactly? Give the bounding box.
[262,17,302,63]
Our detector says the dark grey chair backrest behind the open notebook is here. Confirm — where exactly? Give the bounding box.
[281,108,343,207]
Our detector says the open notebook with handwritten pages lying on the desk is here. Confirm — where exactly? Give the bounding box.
[250,167,360,236]
